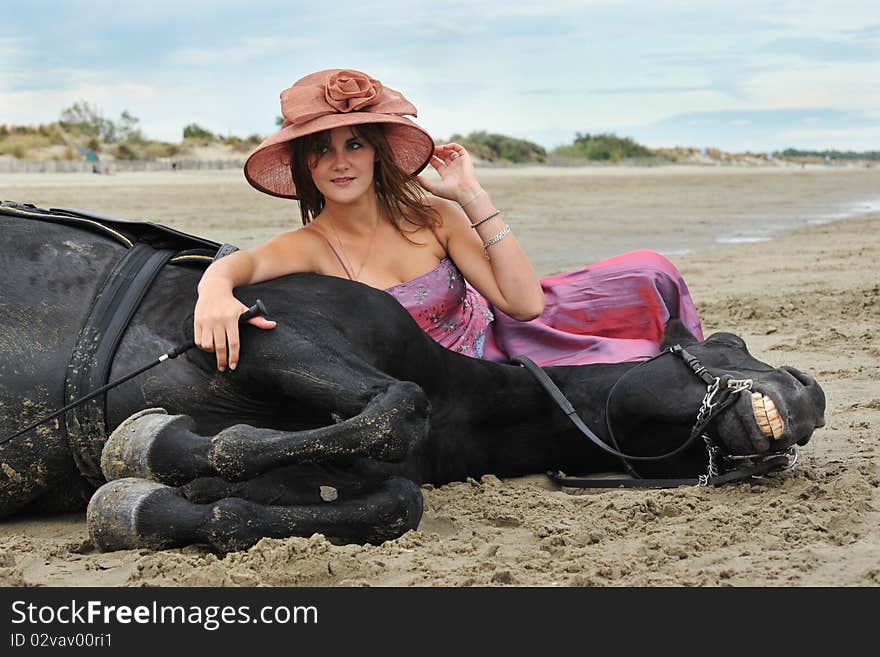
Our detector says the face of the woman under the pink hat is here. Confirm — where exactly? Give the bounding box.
[309,126,376,203]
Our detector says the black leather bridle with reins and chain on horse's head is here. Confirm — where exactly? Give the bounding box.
[511,345,798,488]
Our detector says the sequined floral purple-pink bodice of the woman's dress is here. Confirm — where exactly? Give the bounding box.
[385,256,493,358]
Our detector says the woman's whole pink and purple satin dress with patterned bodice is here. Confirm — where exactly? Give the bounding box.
[310,229,703,366]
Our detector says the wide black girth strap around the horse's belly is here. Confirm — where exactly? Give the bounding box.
[62,242,175,486]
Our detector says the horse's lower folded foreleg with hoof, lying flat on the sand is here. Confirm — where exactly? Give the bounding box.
[87,477,422,552]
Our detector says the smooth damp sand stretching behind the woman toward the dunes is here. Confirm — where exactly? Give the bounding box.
[0,166,880,275]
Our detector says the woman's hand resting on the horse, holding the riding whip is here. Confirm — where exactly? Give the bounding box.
[193,287,275,372]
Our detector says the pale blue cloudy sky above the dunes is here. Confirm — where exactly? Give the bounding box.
[0,0,880,152]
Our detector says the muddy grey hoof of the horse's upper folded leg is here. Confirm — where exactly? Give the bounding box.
[101,408,193,481]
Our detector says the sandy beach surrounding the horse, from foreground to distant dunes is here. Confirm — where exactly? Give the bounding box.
[0,167,880,586]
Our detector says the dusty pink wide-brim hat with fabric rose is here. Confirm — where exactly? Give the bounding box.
[244,69,434,199]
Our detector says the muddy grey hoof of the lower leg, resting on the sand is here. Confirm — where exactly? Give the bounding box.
[86,477,179,552]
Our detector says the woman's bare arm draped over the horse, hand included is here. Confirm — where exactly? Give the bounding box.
[193,230,320,372]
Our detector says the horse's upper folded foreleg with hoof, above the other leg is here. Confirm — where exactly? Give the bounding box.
[101,378,429,485]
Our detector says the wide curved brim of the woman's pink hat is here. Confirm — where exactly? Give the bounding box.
[244,112,434,199]
